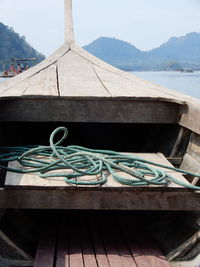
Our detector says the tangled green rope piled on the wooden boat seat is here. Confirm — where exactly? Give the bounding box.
[0,127,200,190]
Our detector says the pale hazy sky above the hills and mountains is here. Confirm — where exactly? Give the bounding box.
[0,0,200,55]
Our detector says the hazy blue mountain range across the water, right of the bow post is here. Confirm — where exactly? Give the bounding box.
[84,32,200,70]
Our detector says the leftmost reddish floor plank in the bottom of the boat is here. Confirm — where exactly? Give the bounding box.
[34,223,57,267]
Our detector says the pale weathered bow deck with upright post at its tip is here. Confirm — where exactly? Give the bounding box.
[0,0,200,134]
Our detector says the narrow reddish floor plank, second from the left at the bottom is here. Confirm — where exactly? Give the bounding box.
[56,216,70,267]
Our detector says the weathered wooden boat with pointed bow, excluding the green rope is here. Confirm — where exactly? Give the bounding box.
[0,0,200,267]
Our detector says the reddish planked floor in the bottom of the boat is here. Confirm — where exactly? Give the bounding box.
[34,212,170,267]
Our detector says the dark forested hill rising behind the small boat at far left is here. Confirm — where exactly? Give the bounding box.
[0,22,45,69]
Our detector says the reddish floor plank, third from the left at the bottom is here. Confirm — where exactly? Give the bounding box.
[69,214,84,267]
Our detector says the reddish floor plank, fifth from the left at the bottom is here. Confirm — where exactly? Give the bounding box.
[89,216,110,267]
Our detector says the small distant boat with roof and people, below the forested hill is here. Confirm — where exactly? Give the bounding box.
[0,58,36,78]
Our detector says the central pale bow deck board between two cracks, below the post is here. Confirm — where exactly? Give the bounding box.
[58,51,109,98]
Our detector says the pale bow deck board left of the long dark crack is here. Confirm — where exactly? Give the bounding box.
[22,64,59,98]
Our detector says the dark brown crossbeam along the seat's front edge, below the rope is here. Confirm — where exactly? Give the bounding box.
[0,187,200,211]
